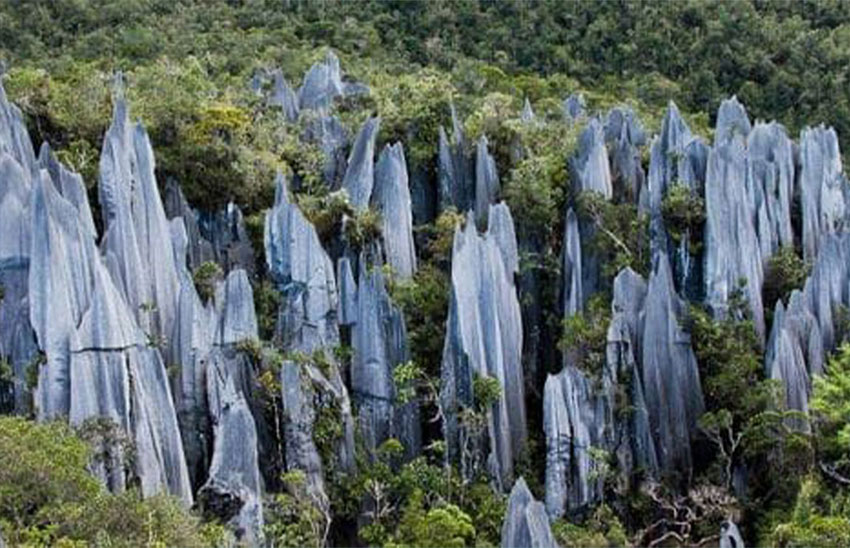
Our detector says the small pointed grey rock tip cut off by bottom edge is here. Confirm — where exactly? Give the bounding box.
[501,478,558,548]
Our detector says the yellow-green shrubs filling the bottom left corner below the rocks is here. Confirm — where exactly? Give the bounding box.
[0,417,219,547]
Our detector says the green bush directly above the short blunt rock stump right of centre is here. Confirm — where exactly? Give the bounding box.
[558,294,611,378]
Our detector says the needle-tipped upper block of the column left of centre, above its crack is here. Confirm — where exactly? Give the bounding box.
[265,176,339,354]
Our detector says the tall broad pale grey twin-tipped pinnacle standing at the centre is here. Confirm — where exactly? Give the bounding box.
[441,204,526,485]
